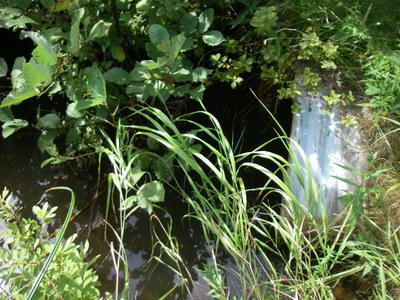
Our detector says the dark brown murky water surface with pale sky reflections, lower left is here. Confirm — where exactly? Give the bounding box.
[0,132,209,299]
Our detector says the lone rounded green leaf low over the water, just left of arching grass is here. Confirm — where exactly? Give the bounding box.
[137,180,165,214]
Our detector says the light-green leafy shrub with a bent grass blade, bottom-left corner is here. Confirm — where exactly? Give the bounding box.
[0,188,100,299]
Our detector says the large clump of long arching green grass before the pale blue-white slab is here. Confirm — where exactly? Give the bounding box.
[101,102,399,299]
